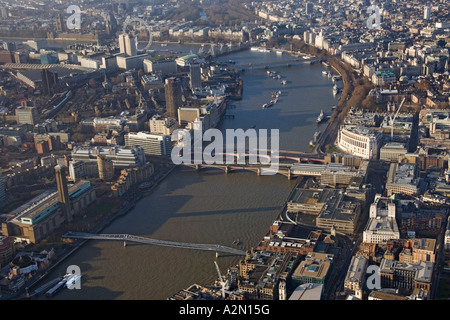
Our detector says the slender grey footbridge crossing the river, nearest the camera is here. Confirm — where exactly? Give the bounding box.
[62,232,246,255]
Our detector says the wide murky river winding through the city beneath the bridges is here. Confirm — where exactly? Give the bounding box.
[44,47,337,300]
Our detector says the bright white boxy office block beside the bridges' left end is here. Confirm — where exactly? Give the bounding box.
[125,131,172,156]
